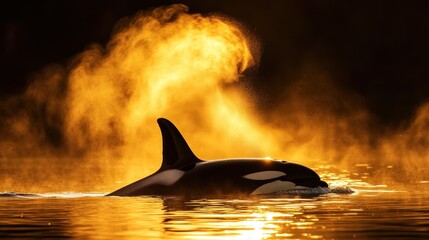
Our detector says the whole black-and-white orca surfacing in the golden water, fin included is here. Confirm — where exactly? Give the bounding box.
[108,118,328,196]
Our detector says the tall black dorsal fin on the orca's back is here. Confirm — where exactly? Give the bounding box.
[158,118,201,171]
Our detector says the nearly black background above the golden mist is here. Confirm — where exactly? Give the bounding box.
[0,0,429,127]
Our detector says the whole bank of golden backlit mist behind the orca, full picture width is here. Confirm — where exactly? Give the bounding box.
[0,5,429,191]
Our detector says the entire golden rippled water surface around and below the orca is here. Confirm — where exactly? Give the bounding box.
[0,166,429,240]
